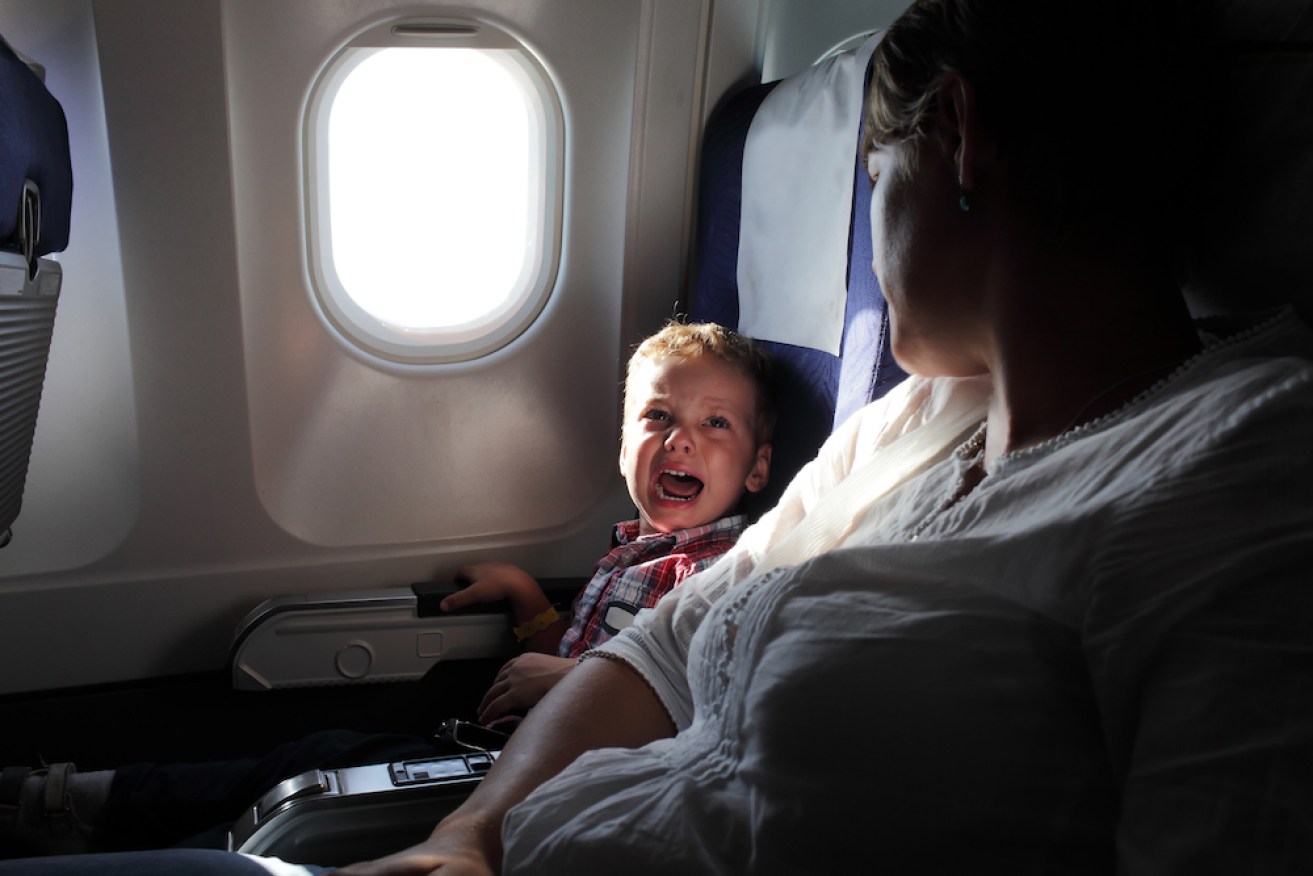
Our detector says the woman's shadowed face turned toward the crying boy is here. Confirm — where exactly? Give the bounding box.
[867,138,983,377]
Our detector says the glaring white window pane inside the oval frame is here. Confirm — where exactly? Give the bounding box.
[328,49,525,328]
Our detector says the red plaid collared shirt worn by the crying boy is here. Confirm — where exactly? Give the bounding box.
[557,515,747,657]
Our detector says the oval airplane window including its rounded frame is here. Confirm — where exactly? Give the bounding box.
[306,28,562,362]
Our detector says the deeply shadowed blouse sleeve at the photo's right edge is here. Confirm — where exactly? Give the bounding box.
[1085,372,1313,876]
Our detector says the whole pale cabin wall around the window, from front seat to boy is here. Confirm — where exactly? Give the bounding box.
[0,0,730,695]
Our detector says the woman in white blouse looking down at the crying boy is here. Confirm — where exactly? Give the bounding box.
[0,0,1313,876]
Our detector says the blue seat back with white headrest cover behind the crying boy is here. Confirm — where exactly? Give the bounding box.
[689,38,906,516]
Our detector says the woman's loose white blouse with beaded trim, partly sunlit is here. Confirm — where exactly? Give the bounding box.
[503,313,1313,876]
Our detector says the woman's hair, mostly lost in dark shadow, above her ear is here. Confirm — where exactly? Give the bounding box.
[865,0,1194,252]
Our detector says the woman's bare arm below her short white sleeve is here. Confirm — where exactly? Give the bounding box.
[337,659,675,876]
